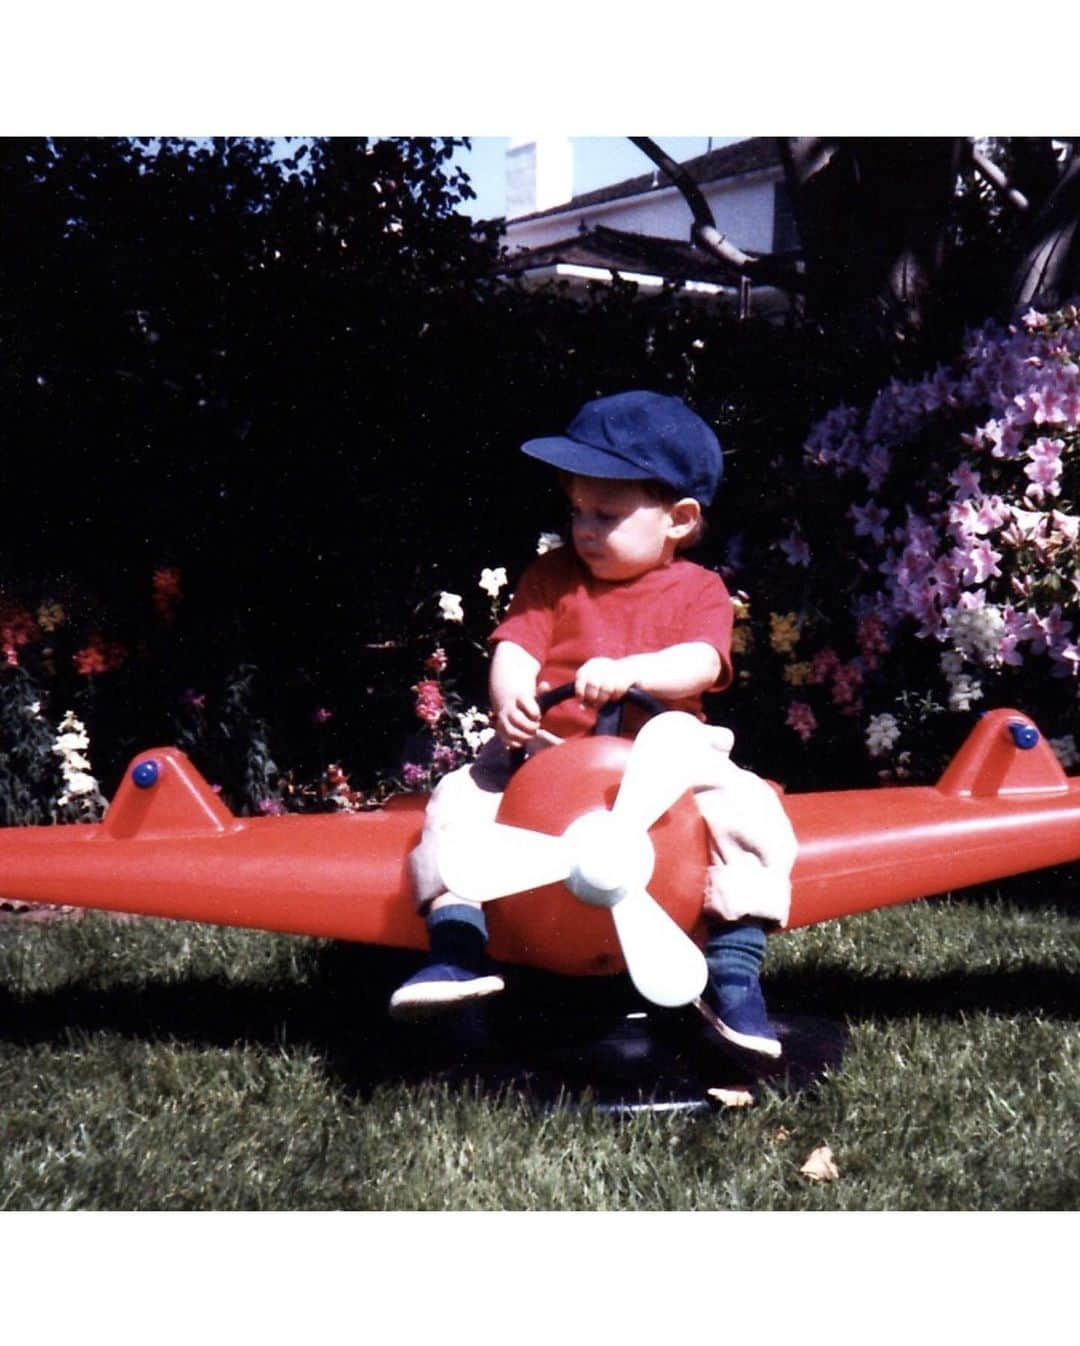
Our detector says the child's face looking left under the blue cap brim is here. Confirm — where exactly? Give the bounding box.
[567,476,679,581]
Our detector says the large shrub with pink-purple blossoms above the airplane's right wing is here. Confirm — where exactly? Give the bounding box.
[737,306,1080,778]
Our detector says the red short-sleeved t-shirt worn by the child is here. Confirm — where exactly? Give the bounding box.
[490,546,733,738]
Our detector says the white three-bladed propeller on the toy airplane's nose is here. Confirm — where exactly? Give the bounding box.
[438,711,718,1008]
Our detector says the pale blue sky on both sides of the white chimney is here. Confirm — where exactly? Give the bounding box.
[454,136,739,219]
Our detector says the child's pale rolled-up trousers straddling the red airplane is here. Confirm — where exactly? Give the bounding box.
[409,724,797,926]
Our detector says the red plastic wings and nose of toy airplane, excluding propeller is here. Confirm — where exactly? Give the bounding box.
[0,711,1080,975]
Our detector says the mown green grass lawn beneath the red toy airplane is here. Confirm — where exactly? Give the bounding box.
[0,871,1080,1210]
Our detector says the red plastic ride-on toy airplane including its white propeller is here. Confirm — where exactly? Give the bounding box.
[0,709,1080,1005]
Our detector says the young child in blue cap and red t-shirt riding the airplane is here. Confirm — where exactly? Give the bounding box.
[391,392,795,1057]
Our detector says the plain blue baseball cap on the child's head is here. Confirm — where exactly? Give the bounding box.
[521,392,723,505]
